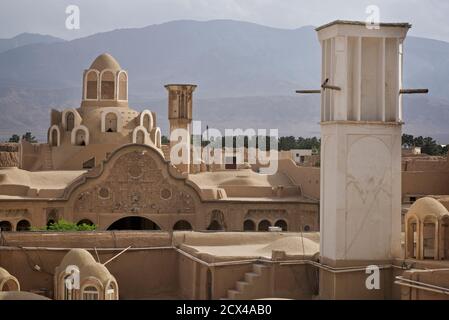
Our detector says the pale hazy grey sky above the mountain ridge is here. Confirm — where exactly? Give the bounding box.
[0,0,449,41]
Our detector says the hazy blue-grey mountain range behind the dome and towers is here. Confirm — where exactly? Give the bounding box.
[0,20,449,144]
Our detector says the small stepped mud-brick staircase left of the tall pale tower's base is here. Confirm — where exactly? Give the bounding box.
[226,264,271,300]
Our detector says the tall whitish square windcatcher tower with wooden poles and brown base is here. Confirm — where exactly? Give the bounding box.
[317,21,411,299]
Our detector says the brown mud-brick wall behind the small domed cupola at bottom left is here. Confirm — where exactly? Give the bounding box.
[0,232,179,299]
